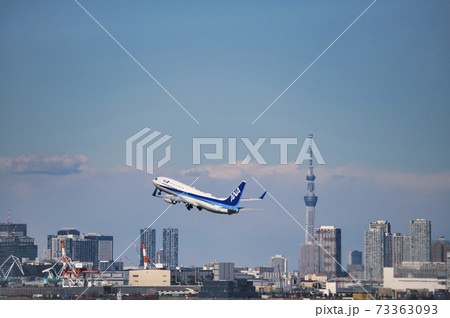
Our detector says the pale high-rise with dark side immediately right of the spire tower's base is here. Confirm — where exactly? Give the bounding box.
[314,225,342,278]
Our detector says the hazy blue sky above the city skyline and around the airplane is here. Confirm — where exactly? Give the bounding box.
[0,0,450,267]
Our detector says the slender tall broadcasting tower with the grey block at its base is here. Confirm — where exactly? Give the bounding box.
[299,135,320,276]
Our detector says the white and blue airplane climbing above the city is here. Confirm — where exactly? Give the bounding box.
[153,177,267,215]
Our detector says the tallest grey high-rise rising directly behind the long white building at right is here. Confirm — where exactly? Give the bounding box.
[409,219,431,262]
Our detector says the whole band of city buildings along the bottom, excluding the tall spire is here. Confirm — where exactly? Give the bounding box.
[0,214,450,299]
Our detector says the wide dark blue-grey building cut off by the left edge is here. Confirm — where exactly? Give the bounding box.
[0,222,37,265]
